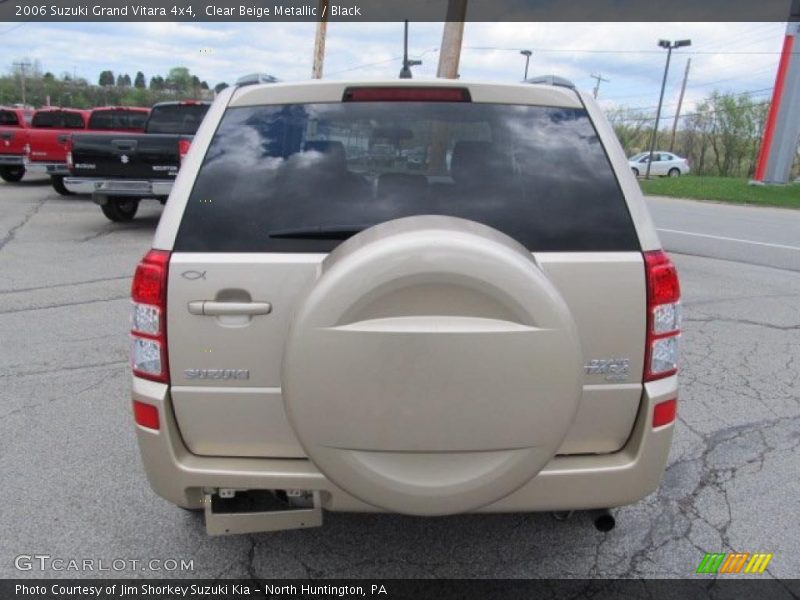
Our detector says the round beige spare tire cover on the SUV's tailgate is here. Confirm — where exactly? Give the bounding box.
[282,216,582,515]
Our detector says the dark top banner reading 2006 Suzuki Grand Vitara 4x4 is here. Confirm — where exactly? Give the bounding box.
[0,0,800,22]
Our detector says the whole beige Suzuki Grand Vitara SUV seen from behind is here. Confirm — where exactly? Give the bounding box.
[131,80,680,534]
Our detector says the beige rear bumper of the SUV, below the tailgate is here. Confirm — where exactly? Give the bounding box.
[133,377,677,512]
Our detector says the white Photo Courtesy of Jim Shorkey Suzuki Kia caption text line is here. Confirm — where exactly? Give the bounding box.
[14,583,390,598]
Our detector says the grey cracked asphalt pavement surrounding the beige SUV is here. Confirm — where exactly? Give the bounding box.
[0,178,800,578]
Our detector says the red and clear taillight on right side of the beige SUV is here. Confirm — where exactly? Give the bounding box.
[644,250,681,381]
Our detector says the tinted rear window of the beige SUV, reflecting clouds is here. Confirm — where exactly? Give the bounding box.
[175,102,639,252]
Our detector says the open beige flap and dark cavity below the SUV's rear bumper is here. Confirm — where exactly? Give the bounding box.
[203,490,322,535]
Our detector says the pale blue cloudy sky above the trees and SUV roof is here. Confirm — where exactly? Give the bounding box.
[0,23,785,116]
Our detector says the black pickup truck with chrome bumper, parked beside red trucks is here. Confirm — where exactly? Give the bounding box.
[64,101,210,221]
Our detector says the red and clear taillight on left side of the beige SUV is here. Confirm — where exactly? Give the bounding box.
[131,250,169,383]
